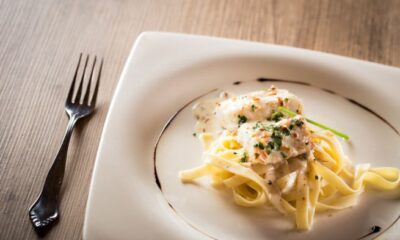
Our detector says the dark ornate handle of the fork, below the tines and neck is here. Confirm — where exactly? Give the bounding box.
[29,115,78,228]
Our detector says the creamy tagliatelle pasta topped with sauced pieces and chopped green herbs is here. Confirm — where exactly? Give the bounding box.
[179,87,400,230]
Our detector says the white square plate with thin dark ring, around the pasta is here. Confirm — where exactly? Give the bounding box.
[83,32,400,240]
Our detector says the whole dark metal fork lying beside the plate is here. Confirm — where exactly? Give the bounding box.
[29,53,103,232]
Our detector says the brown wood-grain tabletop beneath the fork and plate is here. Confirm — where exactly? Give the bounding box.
[0,0,400,239]
